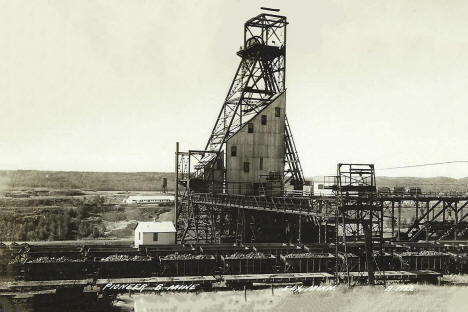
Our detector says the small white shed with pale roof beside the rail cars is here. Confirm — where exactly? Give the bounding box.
[135,221,176,247]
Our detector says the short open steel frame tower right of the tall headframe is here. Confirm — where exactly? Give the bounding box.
[335,164,383,284]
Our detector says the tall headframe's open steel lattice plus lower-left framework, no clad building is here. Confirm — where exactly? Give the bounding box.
[176,9,304,243]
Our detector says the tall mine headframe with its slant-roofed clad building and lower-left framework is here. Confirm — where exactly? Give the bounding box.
[176,8,304,242]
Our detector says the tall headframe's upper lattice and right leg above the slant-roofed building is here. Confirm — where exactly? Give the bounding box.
[196,8,304,189]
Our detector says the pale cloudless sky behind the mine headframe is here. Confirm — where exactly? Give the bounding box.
[0,0,468,178]
